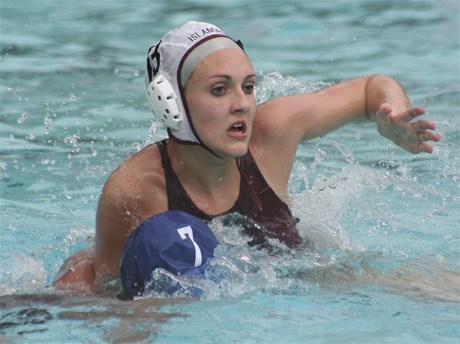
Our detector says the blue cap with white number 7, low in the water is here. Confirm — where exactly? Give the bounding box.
[119,210,218,299]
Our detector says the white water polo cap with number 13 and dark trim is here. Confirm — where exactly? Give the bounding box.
[145,21,243,145]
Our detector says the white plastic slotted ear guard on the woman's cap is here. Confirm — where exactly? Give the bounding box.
[147,74,183,130]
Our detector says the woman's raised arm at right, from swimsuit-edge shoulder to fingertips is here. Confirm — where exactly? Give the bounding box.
[251,75,440,195]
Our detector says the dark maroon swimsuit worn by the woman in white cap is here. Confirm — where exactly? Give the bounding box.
[156,139,302,248]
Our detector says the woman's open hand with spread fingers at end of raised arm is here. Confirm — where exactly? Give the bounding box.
[375,103,441,154]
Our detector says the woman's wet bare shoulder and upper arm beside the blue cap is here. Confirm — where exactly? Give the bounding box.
[94,145,167,275]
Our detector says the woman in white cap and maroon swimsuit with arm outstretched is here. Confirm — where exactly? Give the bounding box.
[56,22,440,292]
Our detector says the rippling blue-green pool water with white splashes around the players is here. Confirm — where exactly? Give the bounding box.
[0,0,460,343]
